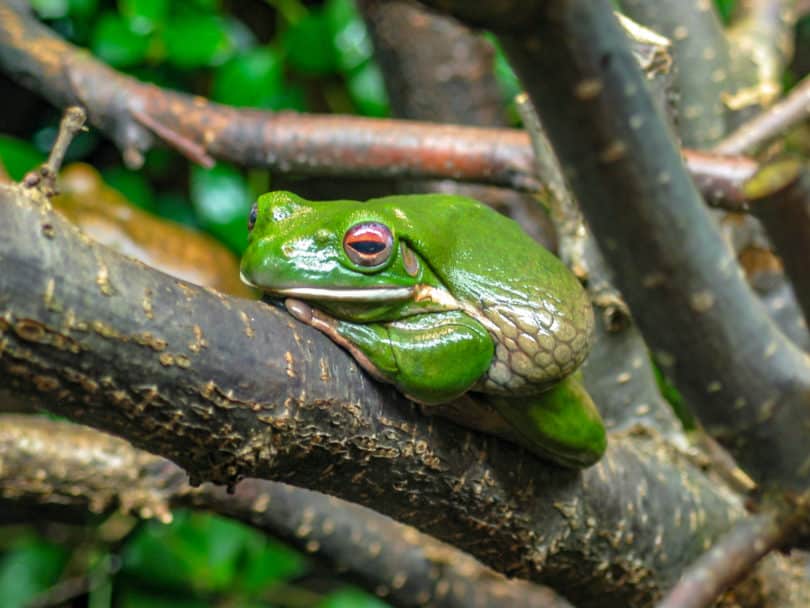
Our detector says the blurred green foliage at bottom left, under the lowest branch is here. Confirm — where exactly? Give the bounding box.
[0,511,386,608]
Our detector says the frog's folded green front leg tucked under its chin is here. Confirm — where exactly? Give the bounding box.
[284,299,494,404]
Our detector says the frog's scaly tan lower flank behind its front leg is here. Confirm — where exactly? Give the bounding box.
[474,301,593,395]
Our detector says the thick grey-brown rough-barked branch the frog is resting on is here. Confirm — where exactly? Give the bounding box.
[0,182,740,605]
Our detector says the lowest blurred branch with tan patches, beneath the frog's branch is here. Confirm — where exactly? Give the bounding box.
[0,415,569,608]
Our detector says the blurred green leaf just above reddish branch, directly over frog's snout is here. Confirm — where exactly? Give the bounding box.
[211,47,284,108]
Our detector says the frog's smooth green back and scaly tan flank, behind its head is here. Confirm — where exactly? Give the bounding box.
[369,194,593,394]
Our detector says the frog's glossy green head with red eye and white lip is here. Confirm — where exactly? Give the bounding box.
[241,191,444,321]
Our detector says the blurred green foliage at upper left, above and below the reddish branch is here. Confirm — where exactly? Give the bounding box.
[12,0,389,254]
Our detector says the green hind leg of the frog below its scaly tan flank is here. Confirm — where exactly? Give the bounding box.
[489,372,607,468]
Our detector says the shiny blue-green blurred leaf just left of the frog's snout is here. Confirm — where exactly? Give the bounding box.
[191,163,253,254]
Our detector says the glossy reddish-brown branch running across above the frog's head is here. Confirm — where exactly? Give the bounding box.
[0,0,764,211]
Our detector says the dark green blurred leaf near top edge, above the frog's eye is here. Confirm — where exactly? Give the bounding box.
[283,11,337,76]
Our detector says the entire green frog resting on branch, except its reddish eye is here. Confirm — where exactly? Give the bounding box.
[241,192,606,467]
